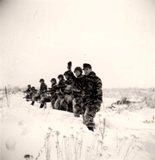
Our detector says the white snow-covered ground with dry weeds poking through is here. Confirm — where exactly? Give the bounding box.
[0,91,155,160]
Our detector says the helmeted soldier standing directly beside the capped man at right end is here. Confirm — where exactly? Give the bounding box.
[73,67,83,117]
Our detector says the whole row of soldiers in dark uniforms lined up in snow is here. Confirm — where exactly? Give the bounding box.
[25,62,102,131]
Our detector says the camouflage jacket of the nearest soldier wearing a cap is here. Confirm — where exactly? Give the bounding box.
[83,71,102,103]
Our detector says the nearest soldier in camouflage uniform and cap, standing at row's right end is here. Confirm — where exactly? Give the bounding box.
[83,63,102,131]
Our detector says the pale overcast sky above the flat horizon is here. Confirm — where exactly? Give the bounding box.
[0,0,155,88]
